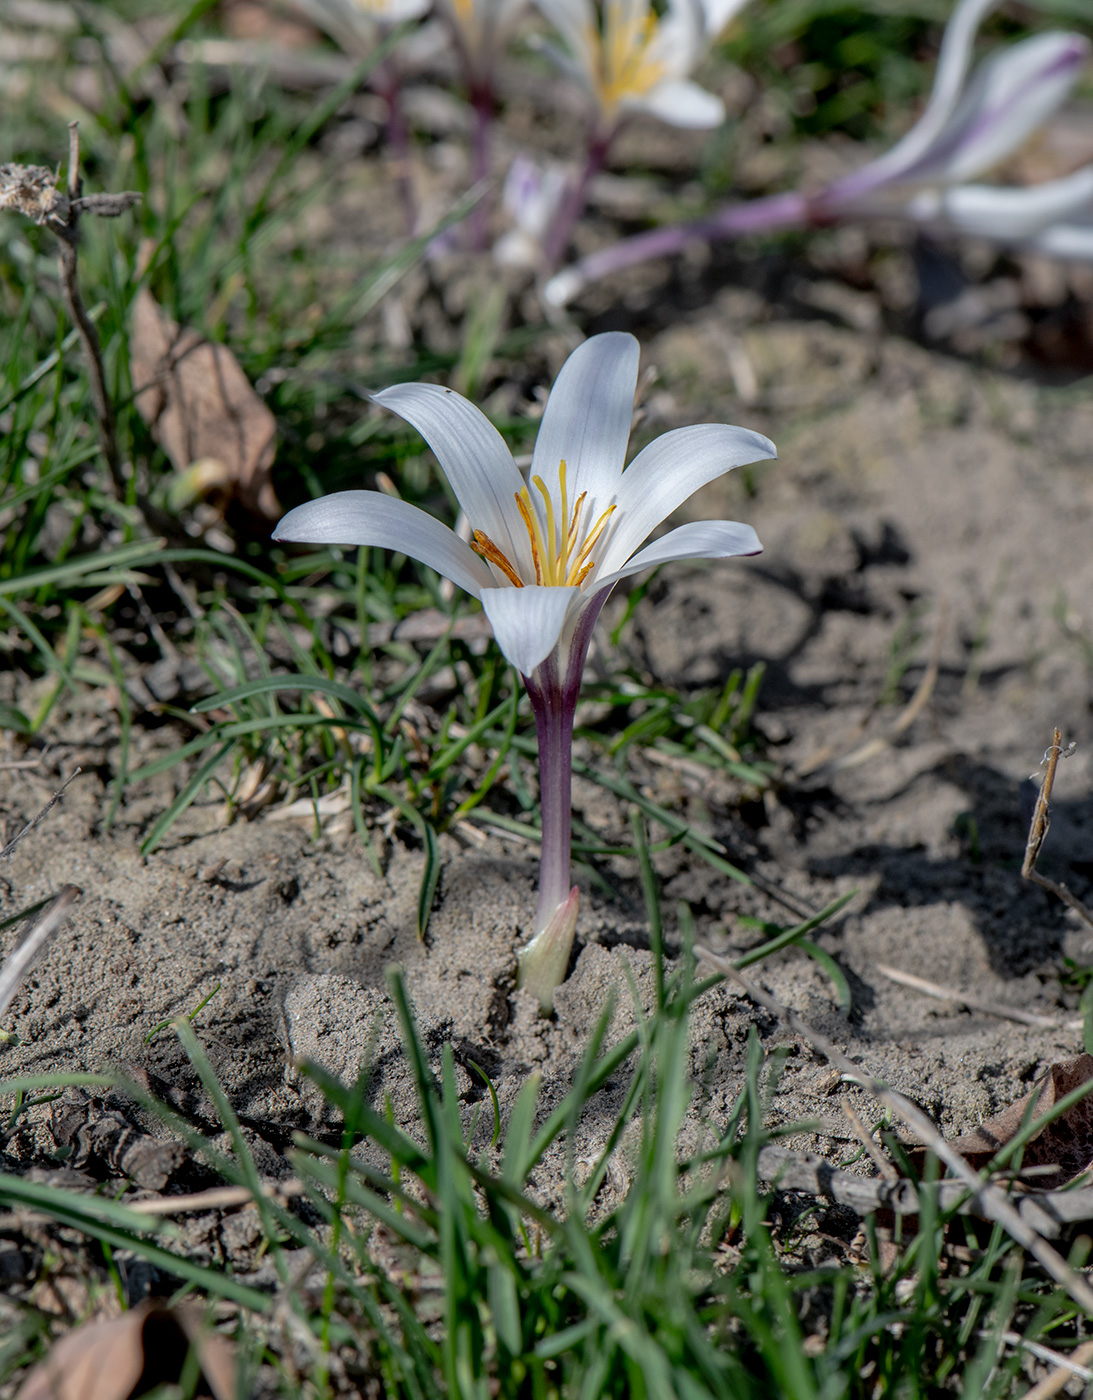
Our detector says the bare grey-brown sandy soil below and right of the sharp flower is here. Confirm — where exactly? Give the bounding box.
[0,312,1093,1254]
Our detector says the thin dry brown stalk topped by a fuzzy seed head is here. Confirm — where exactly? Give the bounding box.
[0,122,140,500]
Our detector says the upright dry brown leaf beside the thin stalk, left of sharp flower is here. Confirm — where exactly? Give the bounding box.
[130,287,281,521]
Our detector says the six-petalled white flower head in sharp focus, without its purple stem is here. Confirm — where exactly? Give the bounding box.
[274,333,775,685]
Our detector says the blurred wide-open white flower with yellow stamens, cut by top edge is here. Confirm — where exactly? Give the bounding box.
[526,0,743,130]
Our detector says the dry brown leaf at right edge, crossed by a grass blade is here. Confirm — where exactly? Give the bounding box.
[952,1054,1093,1190]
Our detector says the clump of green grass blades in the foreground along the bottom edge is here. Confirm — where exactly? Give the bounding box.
[0,912,1075,1400]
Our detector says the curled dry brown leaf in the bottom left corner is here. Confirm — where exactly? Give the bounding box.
[15,1303,235,1400]
